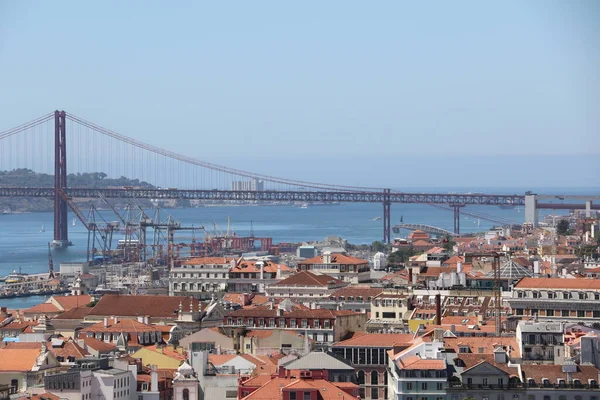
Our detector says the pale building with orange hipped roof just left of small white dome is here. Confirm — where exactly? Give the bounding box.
[297,252,371,284]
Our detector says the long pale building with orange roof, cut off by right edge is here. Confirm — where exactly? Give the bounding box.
[508,278,600,323]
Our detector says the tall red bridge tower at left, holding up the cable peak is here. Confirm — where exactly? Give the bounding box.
[52,111,71,248]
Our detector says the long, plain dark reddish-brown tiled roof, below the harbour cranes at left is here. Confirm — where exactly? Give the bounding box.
[89,294,203,318]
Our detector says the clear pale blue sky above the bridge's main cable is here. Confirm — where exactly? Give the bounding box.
[0,0,600,188]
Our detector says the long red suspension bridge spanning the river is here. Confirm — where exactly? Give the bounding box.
[0,111,600,247]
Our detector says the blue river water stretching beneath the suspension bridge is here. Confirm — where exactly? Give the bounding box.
[0,189,597,308]
